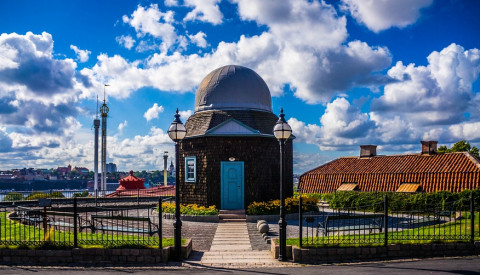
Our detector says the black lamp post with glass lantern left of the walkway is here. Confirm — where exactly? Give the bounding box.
[168,108,187,261]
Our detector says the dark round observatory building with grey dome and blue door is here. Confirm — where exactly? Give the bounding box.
[179,65,293,209]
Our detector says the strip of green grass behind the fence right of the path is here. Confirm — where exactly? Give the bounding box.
[284,215,480,247]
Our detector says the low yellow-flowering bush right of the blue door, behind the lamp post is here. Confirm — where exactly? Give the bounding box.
[247,196,318,215]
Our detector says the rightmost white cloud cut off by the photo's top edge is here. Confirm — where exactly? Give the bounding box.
[342,0,433,32]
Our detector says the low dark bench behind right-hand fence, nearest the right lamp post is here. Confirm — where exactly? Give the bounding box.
[317,214,383,236]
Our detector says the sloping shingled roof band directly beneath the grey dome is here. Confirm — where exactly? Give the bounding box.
[185,110,278,137]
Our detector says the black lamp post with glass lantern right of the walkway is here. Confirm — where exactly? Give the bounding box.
[273,108,292,261]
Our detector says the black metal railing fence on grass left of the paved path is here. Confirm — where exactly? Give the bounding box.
[0,198,172,248]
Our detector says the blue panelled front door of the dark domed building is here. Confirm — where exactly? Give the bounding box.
[221,161,244,210]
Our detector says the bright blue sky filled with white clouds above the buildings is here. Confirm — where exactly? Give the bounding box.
[0,0,480,173]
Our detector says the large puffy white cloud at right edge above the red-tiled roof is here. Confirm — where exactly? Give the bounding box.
[372,44,480,126]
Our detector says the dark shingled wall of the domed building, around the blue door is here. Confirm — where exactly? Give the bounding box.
[179,136,293,208]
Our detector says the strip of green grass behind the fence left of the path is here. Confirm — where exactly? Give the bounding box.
[0,212,186,249]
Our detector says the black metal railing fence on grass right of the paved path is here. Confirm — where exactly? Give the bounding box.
[299,194,480,247]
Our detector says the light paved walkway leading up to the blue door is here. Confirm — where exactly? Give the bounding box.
[185,222,294,267]
